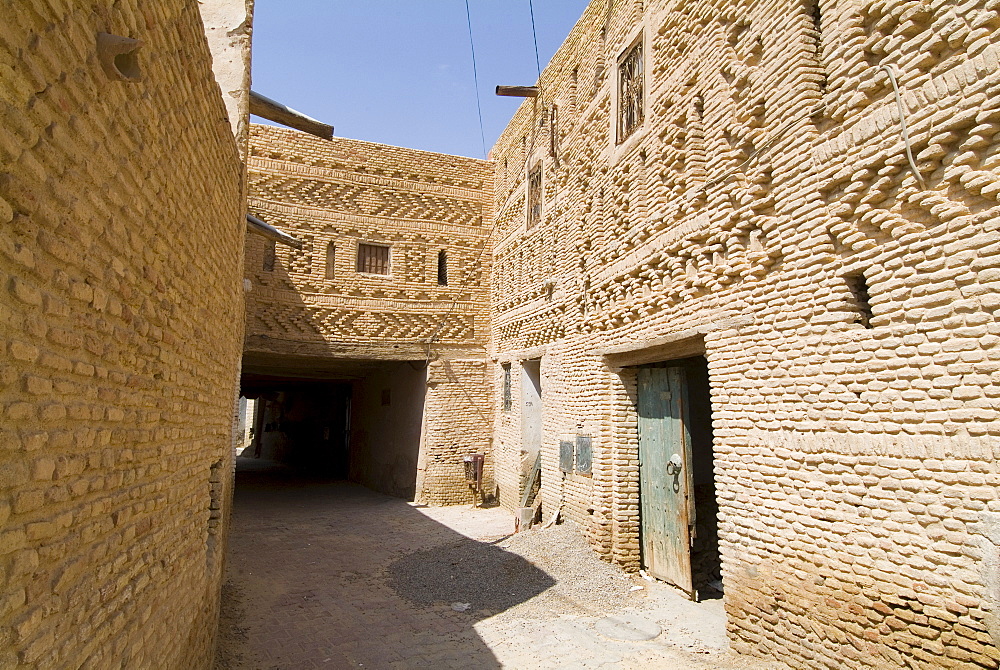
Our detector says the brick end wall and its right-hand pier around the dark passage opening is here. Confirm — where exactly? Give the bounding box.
[246,125,493,504]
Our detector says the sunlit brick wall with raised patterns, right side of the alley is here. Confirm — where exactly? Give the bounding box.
[490,0,1000,668]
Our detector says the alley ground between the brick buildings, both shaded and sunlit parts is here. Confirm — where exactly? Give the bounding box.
[216,459,775,670]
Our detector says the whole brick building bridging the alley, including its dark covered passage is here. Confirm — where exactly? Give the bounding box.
[243,126,493,504]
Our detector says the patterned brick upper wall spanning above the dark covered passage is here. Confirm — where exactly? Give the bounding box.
[246,125,492,358]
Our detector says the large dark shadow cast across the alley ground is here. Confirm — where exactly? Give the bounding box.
[216,459,555,670]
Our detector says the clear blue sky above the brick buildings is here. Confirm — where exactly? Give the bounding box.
[253,0,587,158]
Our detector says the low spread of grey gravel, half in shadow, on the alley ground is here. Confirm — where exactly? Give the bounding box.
[386,522,643,619]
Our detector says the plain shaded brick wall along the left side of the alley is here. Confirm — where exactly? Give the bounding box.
[0,0,245,668]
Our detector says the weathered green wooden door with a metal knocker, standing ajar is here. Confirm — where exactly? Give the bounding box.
[638,367,694,598]
